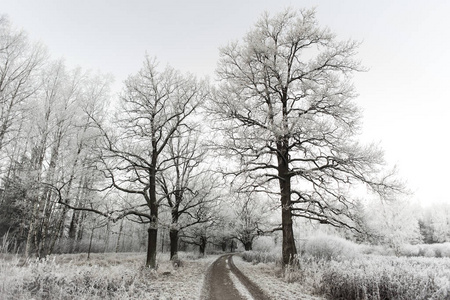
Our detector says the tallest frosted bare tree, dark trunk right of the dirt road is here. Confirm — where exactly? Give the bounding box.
[212,10,398,265]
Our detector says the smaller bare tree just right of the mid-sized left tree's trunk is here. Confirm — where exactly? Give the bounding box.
[158,129,220,259]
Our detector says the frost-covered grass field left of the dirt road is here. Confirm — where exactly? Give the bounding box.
[0,253,217,299]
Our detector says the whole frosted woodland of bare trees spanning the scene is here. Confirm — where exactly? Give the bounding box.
[0,10,450,299]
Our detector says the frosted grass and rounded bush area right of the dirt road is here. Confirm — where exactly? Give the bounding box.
[243,236,450,299]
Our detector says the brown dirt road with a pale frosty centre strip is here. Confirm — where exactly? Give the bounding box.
[202,254,269,300]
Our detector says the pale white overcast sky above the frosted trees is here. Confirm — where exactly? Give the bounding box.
[0,0,450,204]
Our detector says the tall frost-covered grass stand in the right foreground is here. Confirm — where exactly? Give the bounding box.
[316,256,450,300]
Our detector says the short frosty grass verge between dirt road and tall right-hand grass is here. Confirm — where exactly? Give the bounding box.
[233,255,323,300]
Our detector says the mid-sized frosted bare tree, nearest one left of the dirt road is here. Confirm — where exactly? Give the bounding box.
[97,57,207,268]
